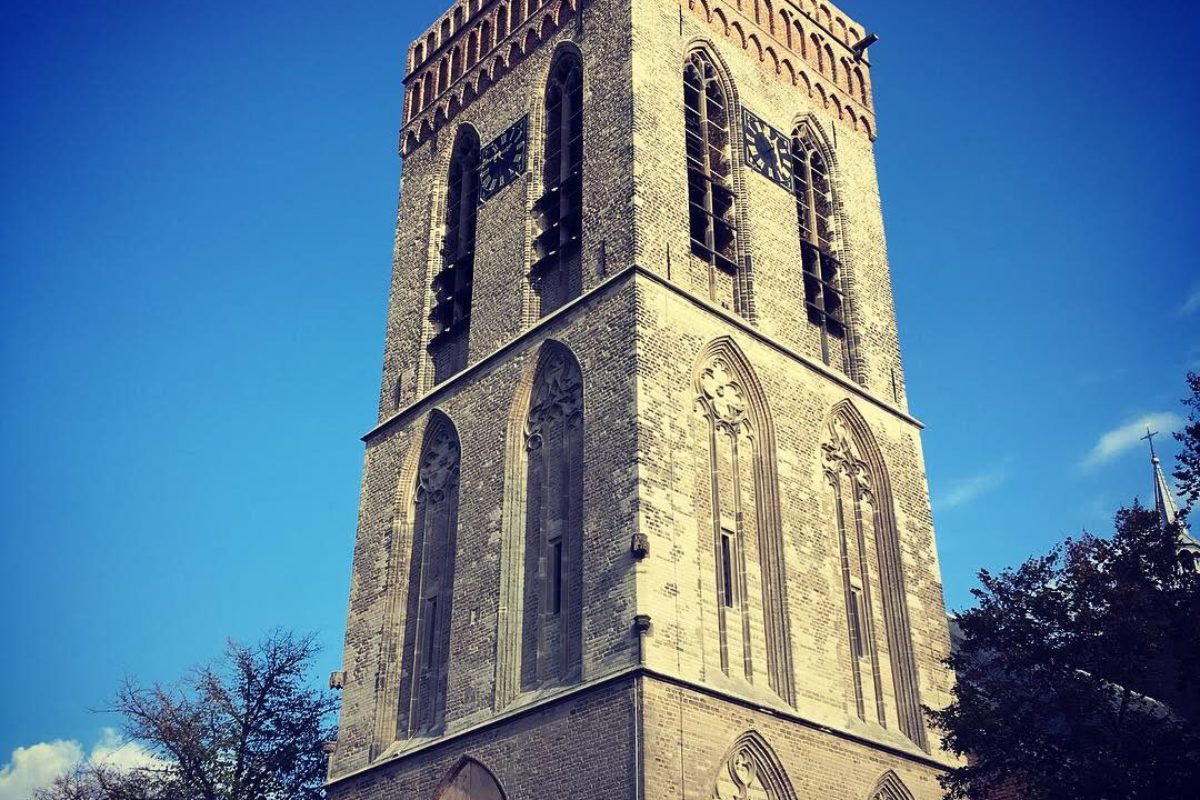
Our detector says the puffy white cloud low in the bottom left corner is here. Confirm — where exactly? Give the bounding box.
[0,728,157,800]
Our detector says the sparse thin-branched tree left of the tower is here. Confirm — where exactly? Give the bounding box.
[40,631,337,800]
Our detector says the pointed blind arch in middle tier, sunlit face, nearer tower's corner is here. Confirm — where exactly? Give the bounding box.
[691,337,796,704]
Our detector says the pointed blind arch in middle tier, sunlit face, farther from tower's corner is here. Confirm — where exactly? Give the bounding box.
[821,401,929,750]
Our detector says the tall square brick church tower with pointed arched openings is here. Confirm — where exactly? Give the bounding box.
[330,0,950,800]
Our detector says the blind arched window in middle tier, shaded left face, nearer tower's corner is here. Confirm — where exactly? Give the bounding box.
[521,344,584,690]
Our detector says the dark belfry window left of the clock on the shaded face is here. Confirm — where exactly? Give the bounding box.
[430,126,479,383]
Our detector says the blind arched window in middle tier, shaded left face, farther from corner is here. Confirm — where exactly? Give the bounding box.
[398,413,460,736]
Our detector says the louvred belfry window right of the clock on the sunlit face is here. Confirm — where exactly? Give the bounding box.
[792,124,850,367]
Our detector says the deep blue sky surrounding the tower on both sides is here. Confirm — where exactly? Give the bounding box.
[0,0,1200,786]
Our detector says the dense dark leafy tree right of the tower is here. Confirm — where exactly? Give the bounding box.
[929,504,1200,800]
